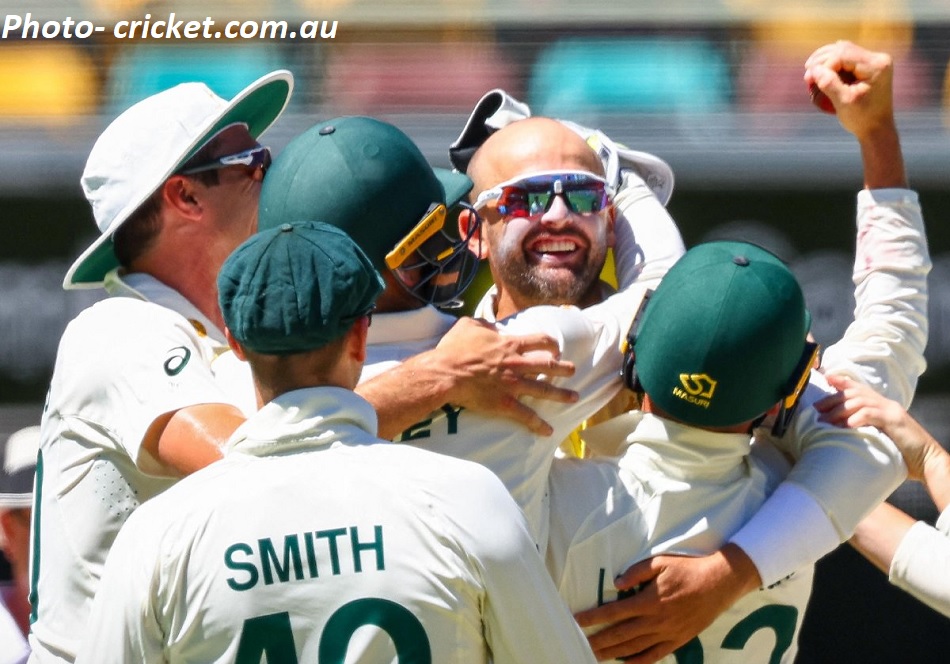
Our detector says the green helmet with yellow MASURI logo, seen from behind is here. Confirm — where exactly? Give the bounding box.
[624,242,818,435]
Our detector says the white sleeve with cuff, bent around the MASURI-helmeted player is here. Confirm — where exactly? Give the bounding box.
[730,372,907,585]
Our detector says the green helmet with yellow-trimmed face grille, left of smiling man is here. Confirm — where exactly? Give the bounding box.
[258,116,480,308]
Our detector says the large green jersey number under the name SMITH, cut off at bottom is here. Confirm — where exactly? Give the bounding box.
[235,598,432,664]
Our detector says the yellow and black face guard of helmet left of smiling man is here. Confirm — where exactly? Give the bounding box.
[385,203,481,309]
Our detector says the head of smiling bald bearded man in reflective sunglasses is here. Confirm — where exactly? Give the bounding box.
[469,118,614,319]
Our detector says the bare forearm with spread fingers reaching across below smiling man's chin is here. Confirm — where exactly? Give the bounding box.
[356,318,577,439]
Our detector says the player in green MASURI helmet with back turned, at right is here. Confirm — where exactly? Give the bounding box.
[548,242,818,662]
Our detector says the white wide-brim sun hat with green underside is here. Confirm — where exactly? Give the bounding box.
[63,69,294,289]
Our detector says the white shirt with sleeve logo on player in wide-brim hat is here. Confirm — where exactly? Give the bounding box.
[30,272,253,663]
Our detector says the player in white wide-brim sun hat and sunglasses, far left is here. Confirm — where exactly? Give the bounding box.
[30,71,293,663]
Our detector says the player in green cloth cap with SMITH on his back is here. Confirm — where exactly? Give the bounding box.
[77,222,594,664]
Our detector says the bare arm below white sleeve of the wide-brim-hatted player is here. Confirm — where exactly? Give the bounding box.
[142,403,245,476]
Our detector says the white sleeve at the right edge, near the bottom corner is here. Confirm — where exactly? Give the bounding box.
[888,509,950,616]
